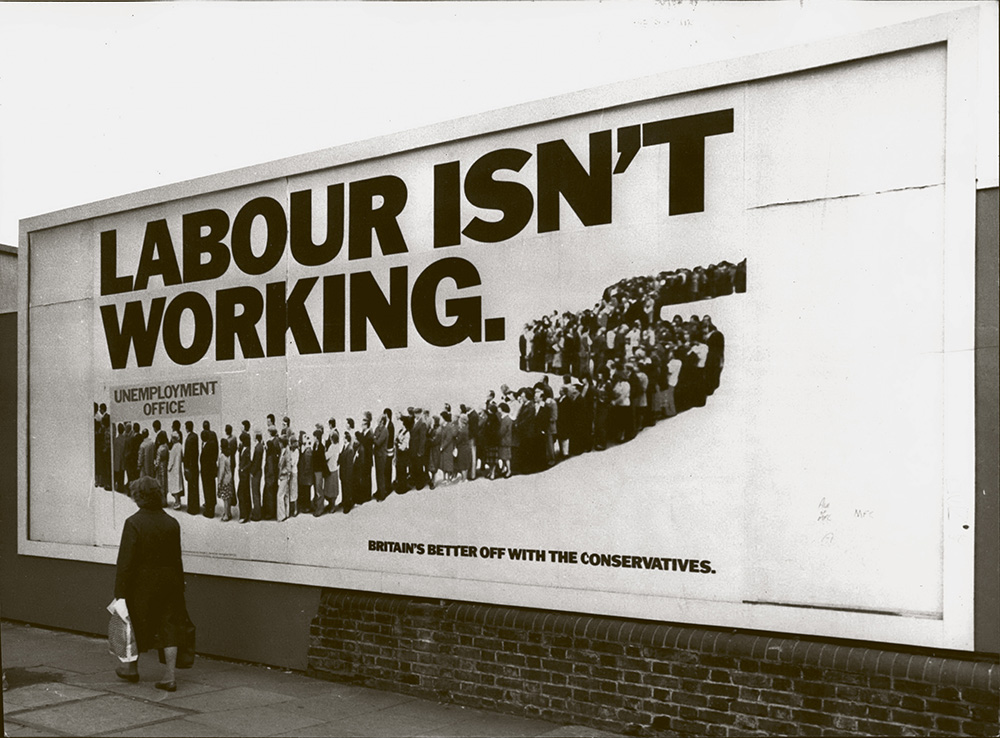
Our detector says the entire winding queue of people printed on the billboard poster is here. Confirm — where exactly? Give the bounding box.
[94,260,746,523]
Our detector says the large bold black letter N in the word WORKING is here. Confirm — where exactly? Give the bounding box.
[351,266,407,351]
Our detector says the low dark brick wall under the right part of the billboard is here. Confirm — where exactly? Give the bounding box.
[309,590,1000,736]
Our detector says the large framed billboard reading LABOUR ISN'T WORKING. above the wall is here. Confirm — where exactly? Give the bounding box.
[19,11,975,648]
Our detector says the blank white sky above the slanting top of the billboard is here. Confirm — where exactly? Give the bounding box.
[0,0,996,250]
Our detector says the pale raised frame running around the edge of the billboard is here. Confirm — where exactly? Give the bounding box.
[17,9,979,650]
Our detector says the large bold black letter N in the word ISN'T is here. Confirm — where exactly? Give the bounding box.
[538,131,611,233]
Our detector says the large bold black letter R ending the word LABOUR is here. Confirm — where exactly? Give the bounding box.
[347,175,406,259]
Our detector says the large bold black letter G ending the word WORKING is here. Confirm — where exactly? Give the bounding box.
[413,256,482,347]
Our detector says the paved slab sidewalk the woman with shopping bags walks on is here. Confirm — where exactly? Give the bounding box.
[0,622,611,738]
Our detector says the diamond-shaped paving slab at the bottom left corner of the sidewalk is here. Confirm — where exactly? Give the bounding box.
[8,695,185,736]
